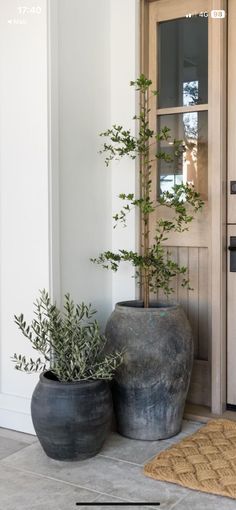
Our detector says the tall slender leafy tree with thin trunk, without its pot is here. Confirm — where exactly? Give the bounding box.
[91,74,203,307]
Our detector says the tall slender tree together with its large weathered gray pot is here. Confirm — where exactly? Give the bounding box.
[91,75,203,440]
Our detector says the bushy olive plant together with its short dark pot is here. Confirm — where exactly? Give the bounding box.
[12,290,122,460]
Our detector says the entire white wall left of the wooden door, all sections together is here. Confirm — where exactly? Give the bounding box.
[0,0,139,432]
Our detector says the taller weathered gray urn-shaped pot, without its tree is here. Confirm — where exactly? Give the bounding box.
[106,301,193,440]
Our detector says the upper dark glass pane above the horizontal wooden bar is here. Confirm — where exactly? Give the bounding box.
[158,16,208,108]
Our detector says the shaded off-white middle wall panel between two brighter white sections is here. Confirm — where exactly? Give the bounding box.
[58,0,111,326]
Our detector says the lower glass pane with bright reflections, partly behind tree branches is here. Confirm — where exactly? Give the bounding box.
[158,111,208,200]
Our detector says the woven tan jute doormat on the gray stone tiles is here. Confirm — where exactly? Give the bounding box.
[144,419,236,499]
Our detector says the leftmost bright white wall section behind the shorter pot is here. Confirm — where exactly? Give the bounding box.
[0,0,49,432]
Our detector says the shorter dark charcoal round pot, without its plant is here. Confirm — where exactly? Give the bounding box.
[31,371,112,460]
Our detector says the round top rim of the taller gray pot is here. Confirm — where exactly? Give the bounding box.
[115,299,182,313]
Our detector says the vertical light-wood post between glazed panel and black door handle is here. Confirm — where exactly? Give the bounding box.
[209,0,227,414]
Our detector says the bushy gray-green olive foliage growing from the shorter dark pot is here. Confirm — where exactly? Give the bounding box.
[12,290,122,382]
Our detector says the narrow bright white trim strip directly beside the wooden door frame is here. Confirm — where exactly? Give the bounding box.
[110,0,139,306]
